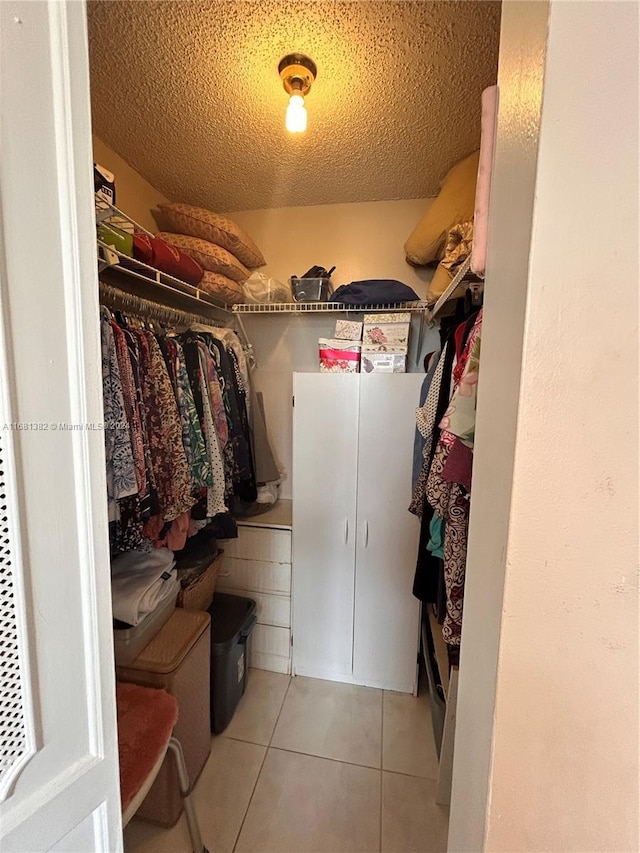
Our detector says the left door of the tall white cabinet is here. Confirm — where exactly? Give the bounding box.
[293,373,360,680]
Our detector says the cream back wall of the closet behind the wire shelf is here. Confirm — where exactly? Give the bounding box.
[229,199,439,498]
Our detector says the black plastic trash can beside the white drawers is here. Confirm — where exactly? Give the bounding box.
[208,592,256,734]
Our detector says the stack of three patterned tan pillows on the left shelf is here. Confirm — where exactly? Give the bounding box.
[153,203,266,304]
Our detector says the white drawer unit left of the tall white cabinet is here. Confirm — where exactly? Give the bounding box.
[217,501,291,674]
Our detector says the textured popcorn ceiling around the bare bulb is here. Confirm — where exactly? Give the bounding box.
[88,0,500,211]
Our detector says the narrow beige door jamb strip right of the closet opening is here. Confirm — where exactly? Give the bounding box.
[449,0,548,853]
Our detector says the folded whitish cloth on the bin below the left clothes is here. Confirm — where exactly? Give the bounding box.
[111,548,179,625]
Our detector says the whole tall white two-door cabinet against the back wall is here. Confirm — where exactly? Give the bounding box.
[293,373,423,692]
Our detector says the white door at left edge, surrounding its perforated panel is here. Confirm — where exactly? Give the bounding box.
[0,0,122,851]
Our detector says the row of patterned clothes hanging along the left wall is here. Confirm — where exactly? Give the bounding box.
[101,308,255,554]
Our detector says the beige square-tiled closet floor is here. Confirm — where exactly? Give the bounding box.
[124,669,448,853]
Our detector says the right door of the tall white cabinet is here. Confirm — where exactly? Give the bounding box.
[353,373,424,692]
